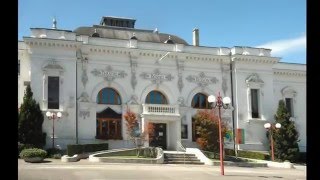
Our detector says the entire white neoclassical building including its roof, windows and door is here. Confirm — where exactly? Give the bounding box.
[18,17,306,151]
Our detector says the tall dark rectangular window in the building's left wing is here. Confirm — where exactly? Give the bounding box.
[48,76,59,109]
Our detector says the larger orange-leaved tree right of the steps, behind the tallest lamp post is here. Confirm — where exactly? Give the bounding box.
[194,110,227,152]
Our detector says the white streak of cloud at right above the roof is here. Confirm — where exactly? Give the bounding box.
[257,33,306,56]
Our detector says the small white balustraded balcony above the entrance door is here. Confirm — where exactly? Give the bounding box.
[142,104,180,116]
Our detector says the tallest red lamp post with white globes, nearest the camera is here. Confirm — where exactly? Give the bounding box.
[208,92,231,175]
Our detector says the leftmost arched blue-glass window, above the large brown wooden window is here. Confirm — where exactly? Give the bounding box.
[97,88,121,105]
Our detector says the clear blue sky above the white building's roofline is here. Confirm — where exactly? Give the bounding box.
[18,0,306,64]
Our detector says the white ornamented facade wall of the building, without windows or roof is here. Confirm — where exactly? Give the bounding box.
[18,29,306,150]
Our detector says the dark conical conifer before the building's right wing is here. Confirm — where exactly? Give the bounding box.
[272,100,300,162]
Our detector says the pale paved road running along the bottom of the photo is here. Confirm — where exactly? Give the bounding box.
[18,159,306,180]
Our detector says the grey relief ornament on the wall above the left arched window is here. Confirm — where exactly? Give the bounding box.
[91,65,127,82]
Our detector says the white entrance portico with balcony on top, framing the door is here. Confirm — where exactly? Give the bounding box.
[141,104,181,150]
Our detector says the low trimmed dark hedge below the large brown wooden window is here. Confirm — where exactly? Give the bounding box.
[67,143,109,156]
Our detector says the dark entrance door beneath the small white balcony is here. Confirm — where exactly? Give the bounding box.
[149,123,167,149]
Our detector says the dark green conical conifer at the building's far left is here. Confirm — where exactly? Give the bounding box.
[18,85,46,148]
